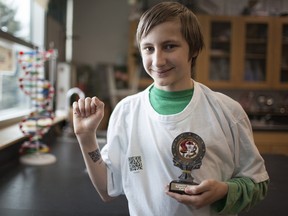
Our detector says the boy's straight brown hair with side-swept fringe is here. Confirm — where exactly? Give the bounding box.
[136,2,204,66]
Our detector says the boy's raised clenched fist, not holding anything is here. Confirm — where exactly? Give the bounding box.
[73,97,104,135]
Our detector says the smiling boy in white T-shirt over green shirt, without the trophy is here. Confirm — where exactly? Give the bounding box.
[73,2,269,216]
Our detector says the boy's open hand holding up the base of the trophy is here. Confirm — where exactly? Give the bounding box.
[166,180,228,209]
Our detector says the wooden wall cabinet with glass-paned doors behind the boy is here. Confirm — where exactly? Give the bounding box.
[196,15,288,89]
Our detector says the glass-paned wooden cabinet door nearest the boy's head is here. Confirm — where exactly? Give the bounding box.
[196,16,235,88]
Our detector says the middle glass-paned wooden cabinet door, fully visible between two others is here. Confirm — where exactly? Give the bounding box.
[238,17,274,88]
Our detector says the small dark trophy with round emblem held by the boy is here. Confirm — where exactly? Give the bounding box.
[169,132,206,194]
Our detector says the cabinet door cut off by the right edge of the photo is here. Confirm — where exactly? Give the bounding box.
[274,18,288,89]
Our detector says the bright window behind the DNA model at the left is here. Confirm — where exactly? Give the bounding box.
[0,0,46,127]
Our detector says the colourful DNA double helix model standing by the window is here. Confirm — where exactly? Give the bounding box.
[18,49,55,159]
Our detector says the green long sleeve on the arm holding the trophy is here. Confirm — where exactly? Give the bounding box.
[212,177,269,214]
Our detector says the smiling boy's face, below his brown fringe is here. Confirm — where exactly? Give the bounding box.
[140,20,193,91]
